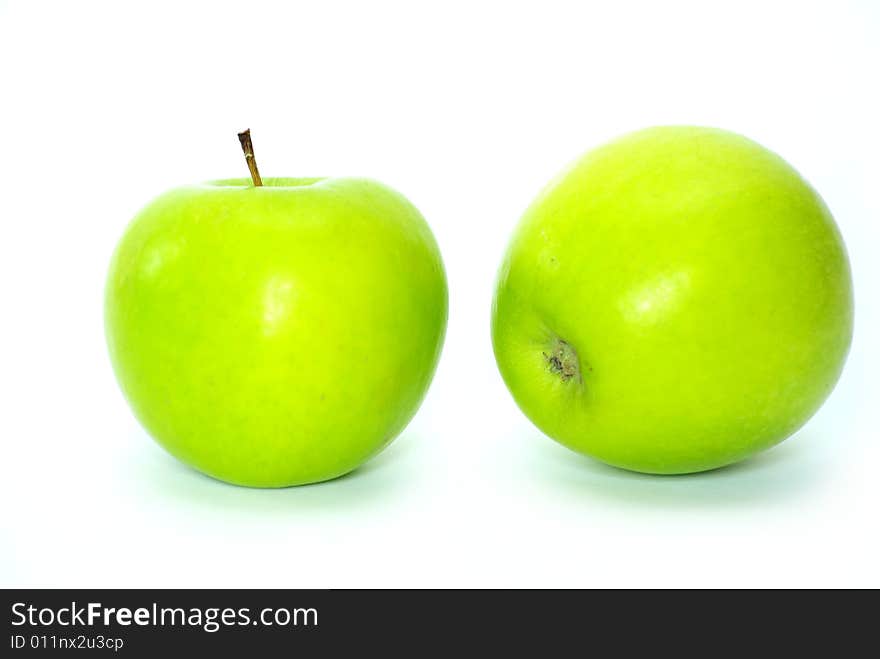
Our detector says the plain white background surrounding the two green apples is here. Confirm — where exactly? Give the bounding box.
[0,0,880,587]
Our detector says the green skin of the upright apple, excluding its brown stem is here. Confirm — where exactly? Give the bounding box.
[105,178,447,487]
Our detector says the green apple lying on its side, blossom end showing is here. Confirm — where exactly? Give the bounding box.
[492,126,853,474]
